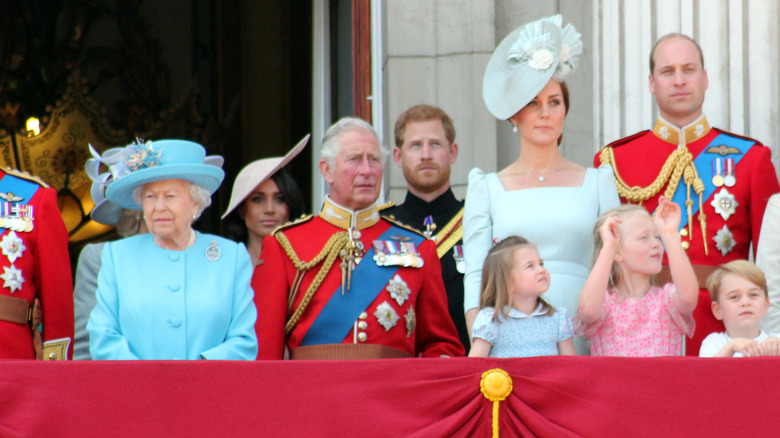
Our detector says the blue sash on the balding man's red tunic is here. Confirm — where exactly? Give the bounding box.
[672,134,756,230]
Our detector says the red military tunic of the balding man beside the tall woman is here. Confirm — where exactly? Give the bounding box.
[594,116,780,356]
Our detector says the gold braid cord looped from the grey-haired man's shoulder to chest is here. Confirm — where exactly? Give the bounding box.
[274,231,349,335]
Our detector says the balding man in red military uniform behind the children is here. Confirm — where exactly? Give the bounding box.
[595,34,780,356]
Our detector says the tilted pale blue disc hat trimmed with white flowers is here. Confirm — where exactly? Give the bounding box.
[482,15,582,120]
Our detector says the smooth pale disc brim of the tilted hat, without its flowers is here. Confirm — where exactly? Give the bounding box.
[482,19,562,120]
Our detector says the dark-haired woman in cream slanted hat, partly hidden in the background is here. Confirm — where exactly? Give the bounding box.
[222,135,309,265]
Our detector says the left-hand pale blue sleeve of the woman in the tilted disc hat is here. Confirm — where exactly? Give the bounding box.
[463,168,493,312]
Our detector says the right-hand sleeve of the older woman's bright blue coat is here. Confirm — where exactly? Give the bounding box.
[201,243,257,360]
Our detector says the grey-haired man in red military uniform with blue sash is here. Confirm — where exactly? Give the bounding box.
[252,118,464,359]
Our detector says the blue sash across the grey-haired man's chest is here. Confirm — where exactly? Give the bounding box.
[301,226,425,346]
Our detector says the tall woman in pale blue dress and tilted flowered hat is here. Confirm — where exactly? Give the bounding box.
[463,16,620,354]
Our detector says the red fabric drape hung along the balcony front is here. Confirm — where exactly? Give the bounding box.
[0,357,780,437]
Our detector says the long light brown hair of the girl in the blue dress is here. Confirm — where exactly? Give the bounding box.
[479,236,555,321]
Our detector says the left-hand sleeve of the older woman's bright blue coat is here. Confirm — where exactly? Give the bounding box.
[87,242,138,360]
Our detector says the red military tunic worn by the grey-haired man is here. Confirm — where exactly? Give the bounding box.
[252,199,464,359]
